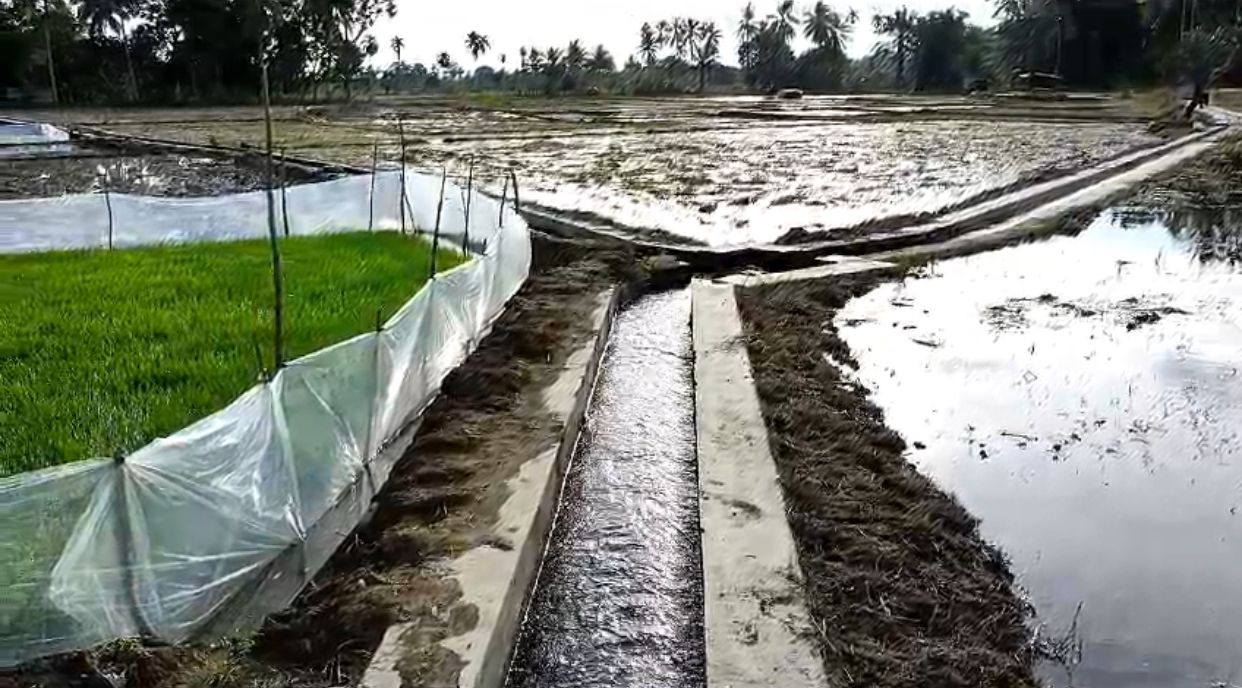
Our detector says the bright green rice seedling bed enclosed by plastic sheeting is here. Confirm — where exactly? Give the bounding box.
[0,232,462,476]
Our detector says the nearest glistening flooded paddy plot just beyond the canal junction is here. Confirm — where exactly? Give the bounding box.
[422,119,1160,246]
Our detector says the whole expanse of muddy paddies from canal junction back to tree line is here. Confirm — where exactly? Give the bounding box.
[4,97,1160,245]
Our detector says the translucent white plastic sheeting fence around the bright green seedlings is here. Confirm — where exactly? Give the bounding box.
[0,167,530,666]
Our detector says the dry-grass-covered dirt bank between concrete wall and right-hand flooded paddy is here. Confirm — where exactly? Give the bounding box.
[739,277,1036,688]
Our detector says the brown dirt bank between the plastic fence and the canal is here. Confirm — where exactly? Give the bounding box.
[0,243,632,688]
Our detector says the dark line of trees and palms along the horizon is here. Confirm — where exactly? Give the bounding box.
[0,0,1242,103]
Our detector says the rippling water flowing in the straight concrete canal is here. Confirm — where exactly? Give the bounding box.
[508,289,704,688]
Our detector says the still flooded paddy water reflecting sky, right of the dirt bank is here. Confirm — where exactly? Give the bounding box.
[838,209,1242,688]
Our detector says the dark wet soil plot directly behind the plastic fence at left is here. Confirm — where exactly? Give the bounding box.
[0,145,332,200]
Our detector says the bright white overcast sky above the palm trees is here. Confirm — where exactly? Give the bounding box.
[373,0,992,68]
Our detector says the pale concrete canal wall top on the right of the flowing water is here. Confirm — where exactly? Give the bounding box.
[692,282,826,688]
